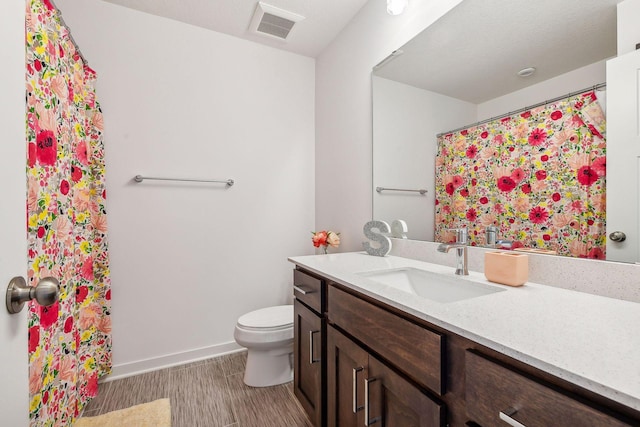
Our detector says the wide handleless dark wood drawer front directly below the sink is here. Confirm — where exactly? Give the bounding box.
[328,286,444,394]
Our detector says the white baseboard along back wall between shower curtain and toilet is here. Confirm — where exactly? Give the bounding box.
[100,341,244,382]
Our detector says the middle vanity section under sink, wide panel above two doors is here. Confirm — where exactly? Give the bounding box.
[327,286,445,427]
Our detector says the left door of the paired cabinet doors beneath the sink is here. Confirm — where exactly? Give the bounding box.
[327,326,369,427]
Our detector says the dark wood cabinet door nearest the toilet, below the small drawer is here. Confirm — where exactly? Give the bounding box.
[293,300,325,427]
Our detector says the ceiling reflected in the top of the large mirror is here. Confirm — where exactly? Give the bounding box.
[375,0,621,104]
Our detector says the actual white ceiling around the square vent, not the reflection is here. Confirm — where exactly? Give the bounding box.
[100,0,370,58]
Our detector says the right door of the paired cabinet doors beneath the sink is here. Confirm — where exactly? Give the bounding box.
[363,355,445,427]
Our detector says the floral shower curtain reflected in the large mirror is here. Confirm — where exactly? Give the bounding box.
[436,91,606,259]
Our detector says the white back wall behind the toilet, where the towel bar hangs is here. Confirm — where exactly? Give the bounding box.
[56,0,315,377]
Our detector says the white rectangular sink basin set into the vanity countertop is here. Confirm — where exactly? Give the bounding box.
[358,267,506,303]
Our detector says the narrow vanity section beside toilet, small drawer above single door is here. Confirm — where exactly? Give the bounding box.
[293,270,326,427]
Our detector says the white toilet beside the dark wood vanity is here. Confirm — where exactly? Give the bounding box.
[233,305,293,387]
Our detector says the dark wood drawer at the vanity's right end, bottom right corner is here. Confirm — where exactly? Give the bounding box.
[465,351,630,427]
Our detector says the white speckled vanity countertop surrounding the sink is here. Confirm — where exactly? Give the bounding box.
[289,252,640,410]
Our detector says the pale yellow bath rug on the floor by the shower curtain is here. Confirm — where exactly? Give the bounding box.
[73,399,171,427]
